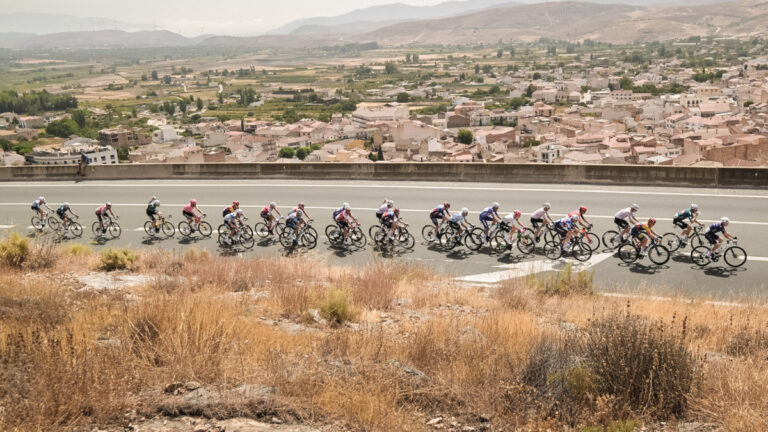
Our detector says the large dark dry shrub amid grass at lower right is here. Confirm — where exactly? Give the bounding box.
[580,313,697,418]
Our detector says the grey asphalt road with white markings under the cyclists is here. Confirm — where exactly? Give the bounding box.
[0,180,768,299]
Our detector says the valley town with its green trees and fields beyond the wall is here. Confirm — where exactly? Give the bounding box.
[0,37,768,167]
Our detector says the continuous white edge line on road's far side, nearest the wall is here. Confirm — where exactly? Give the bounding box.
[0,183,768,199]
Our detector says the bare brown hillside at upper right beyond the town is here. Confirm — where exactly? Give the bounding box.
[359,1,768,45]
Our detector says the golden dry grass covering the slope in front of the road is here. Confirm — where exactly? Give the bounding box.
[0,244,768,431]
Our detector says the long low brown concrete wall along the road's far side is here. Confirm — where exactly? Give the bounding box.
[0,163,768,188]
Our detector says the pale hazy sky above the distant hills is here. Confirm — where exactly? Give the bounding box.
[0,0,441,36]
